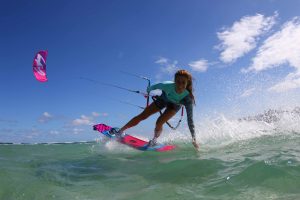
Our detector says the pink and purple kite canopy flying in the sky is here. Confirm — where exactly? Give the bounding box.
[33,50,48,82]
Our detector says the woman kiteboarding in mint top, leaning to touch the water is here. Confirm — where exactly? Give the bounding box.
[112,70,199,150]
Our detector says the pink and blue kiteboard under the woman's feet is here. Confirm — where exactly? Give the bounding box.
[93,124,176,152]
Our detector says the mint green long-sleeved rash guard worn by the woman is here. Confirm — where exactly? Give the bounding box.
[147,81,195,138]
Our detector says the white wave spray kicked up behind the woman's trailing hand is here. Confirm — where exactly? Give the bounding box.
[159,108,300,145]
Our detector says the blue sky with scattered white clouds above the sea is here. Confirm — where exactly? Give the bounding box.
[0,0,300,142]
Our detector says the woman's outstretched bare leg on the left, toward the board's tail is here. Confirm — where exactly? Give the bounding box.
[120,102,160,132]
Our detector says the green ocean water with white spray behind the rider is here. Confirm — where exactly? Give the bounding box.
[0,111,300,200]
